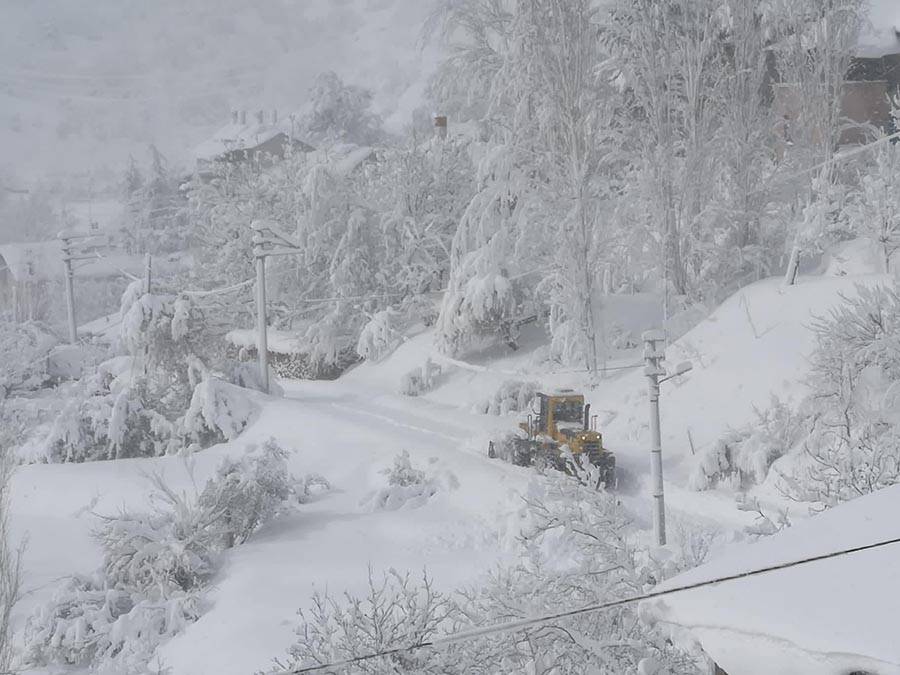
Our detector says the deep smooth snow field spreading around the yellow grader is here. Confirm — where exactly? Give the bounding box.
[11,238,886,675]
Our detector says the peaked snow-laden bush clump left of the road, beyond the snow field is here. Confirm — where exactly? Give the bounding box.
[32,282,256,462]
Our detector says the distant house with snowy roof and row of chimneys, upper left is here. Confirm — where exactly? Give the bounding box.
[193,110,314,175]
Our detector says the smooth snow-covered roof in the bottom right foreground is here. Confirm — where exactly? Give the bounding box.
[642,486,900,675]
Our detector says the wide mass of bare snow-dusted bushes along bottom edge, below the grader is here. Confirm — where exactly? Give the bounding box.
[280,465,709,675]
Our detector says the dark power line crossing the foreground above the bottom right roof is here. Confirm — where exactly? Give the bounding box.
[271,537,900,675]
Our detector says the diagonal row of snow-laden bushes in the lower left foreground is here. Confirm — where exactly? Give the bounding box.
[25,442,306,674]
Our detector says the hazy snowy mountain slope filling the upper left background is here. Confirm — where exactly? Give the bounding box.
[0,0,435,182]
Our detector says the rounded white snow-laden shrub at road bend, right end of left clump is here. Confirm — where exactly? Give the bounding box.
[181,376,257,446]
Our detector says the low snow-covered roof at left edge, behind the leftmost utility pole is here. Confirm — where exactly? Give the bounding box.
[0,239,153,282]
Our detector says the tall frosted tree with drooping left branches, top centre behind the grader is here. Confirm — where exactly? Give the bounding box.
[437,0,617,370]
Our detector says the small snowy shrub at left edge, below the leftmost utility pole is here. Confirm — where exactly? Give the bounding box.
[0,321,59,398]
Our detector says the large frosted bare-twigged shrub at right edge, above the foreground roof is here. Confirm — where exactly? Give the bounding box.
[782,285,900,507]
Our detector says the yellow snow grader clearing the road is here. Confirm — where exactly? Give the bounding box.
[488,389,616,488]
